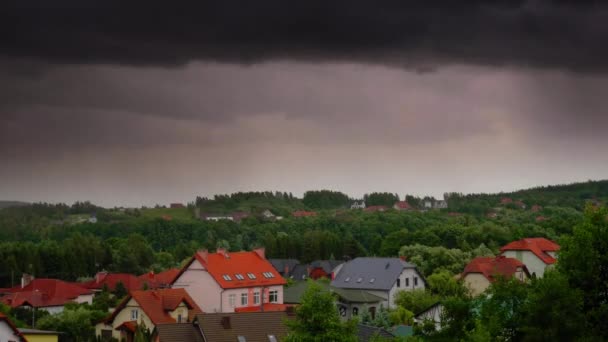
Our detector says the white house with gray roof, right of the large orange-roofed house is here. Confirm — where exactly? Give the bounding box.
[331,258,426,308]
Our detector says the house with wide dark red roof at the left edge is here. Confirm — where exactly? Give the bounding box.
[0,278,93,314]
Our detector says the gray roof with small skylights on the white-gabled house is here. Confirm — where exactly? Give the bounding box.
[331,258,424,291]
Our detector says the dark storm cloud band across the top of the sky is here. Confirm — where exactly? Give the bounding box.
[0,0,608,72]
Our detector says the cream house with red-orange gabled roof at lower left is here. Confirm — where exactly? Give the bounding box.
[95,289,203,341]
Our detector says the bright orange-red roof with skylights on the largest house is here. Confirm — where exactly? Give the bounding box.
[175,248,287,289]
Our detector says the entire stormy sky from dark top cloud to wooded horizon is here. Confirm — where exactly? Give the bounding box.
[0,0,608,207]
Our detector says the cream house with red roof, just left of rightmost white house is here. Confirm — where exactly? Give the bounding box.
[461,255,530,296]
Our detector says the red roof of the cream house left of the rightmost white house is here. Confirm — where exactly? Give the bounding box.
[462,256,530,282]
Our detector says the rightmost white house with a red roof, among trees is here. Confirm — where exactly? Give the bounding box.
[500,238,559,277]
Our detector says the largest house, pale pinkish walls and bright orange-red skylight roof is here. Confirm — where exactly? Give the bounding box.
[173,248,287,312]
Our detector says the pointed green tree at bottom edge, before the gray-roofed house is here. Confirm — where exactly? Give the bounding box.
[284,280,358,342]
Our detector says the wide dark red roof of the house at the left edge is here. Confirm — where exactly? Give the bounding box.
[0,278,93,308]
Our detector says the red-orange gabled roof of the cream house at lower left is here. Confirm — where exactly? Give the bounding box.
[104,289,203,325]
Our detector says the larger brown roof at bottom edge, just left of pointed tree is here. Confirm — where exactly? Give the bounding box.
[195,311,292,342]
